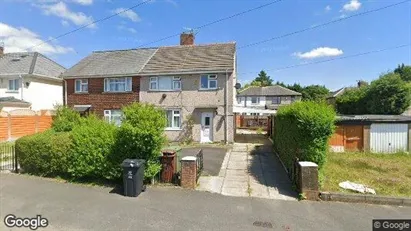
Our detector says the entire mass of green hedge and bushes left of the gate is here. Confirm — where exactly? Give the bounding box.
[15,103,166,182]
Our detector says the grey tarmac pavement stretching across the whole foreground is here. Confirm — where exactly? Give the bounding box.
[0,173,411,231]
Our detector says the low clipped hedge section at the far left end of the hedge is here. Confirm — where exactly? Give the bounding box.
[16,130,71,176]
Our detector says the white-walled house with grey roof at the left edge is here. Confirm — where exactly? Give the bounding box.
[0,47,65,111]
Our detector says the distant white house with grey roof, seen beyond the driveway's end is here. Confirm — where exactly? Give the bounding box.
[234,85,301,115]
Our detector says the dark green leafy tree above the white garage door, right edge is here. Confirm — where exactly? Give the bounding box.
[367,72,410,115]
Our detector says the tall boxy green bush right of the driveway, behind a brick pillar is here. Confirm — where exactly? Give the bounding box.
[273,101,335,171]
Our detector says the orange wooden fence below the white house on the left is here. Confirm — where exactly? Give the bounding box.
[0,109,54,142]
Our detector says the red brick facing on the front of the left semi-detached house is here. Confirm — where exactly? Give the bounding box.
[67,77,140,116]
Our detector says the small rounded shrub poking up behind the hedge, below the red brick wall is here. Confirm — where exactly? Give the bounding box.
[52,106,81,132]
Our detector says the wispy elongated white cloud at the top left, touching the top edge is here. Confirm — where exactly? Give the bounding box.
[40,2,96,28]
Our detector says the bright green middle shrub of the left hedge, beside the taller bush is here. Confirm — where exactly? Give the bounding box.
[68,115,121,179]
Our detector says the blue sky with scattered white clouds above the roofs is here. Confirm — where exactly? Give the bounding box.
[0,0,411,90]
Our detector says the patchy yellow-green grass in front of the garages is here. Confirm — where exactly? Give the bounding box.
[320,152,411,197]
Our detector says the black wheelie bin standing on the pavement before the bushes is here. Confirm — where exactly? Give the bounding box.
[121,159,145,197]
